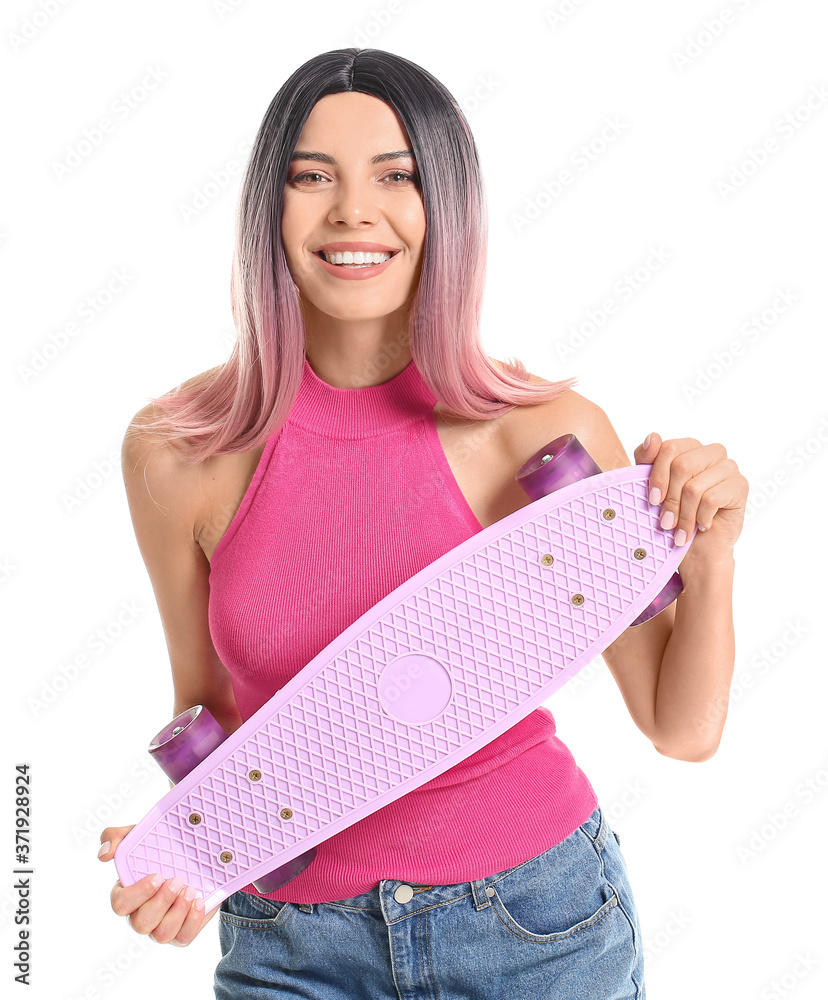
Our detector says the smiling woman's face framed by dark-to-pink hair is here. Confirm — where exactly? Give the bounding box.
[282,91,425,328]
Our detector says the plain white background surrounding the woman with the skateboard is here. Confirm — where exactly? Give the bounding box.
[0,0,828,1000]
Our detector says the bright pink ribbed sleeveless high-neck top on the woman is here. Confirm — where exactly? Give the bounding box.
[209,358,598,903]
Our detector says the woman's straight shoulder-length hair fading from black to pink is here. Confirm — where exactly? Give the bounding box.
[130,48,577,462]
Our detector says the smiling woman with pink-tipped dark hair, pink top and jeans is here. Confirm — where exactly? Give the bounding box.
[99,48,748,1000]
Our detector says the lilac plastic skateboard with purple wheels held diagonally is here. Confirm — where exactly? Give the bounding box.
[115,434,697,910]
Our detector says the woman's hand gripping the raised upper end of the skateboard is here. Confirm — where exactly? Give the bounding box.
[633,433,750,560]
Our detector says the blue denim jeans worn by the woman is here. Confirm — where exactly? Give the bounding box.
[215,806,646,1000]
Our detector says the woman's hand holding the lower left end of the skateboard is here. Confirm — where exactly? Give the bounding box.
[98,823,218,947]
